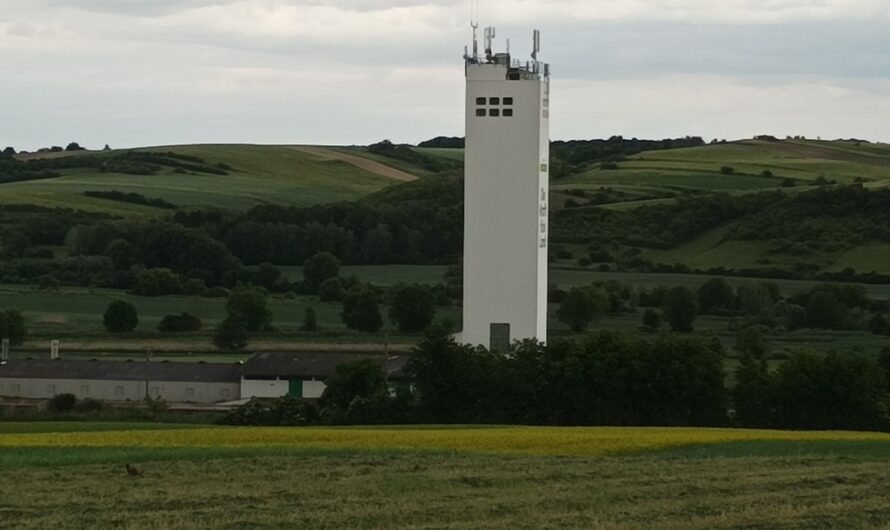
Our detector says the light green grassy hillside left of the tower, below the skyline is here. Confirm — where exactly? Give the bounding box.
[0,145,411,215]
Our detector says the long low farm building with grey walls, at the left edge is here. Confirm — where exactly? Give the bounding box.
[0,359,241,403]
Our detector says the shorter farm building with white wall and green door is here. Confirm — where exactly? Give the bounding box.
[241,353,408,399]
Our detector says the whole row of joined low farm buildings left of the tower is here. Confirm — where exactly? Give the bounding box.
[0,353,407,403]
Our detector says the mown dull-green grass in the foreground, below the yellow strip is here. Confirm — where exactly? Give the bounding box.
[0,454,890,530]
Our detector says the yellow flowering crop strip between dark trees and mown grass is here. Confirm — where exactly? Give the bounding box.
[0,427,890,456]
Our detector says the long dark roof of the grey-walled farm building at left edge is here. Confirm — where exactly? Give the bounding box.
[0,359,241,383]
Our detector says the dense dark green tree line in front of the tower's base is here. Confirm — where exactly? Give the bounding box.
[227,326,890,430]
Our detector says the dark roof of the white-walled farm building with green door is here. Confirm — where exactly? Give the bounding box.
[243,352,408,379]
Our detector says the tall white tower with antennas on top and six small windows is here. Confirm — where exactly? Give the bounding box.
[459,26,550,351]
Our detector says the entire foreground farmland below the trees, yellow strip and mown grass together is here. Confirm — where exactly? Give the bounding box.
[0,423,890,529]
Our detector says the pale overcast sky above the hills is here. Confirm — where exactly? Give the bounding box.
[0,0,890,149]
